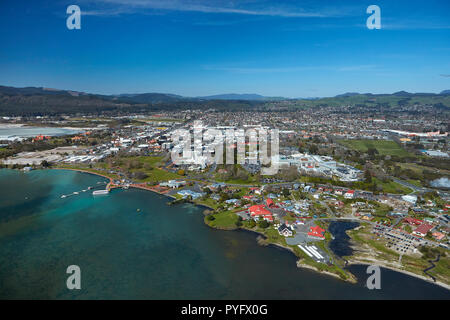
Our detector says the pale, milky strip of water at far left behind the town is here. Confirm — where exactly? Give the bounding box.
[0,127,80,140]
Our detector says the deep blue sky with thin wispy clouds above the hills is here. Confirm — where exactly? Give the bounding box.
[0,0,450,97]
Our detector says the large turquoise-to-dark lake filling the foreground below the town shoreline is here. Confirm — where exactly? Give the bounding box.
[0,169,450,299]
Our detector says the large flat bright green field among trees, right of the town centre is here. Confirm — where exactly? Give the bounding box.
[339,140,412,157]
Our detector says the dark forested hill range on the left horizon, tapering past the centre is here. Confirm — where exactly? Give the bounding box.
[0,86,263,116]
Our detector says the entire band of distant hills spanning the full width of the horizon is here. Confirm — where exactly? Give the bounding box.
[0,86,450,115]
